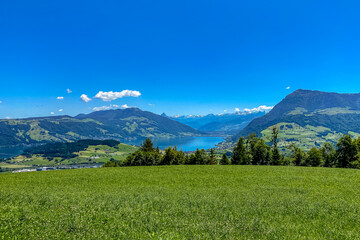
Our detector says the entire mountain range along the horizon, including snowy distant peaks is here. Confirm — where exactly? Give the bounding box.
[0,89,360,149]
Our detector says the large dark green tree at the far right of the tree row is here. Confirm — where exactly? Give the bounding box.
[336,135,358,168]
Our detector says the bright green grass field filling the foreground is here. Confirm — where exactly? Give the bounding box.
[0,166,360,239]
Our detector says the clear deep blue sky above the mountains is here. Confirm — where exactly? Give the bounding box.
[0,0,360,118]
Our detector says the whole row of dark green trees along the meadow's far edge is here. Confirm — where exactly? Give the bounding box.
[104,127,360,168]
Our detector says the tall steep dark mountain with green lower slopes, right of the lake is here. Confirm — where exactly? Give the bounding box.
[232,90,360,147]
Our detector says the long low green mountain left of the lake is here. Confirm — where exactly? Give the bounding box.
[0,108,199,145]
